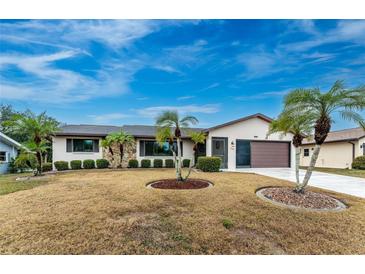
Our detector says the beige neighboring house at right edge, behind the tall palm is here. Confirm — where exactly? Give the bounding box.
[300,128,365,168]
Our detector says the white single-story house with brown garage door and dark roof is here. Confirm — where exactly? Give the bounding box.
[53,113,295,170]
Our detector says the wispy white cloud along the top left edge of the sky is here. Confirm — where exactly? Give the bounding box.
[0,20,159,48]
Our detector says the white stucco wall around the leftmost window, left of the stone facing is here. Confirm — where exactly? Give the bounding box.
[52,136,103,168]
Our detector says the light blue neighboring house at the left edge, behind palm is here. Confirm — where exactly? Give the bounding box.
[0,132,24,174]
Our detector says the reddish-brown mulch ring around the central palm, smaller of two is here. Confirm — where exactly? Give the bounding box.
[146,179,213,190]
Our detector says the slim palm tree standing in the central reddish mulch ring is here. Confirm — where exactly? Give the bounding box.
[156,111,198,182]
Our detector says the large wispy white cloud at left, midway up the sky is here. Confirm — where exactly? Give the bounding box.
[0,51,138,104]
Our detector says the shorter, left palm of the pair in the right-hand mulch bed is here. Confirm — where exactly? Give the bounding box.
[269,111,315,188]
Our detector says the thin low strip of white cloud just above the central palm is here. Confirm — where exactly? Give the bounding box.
[136,104,219,117]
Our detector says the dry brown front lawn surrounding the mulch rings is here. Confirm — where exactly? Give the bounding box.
[0,169,365,254]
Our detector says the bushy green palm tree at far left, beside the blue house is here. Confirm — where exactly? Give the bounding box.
[4,111,59,175]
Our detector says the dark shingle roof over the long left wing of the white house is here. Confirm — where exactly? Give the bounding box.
[56,125,203,138]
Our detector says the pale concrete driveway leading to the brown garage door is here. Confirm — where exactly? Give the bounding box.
[228,168,365,198]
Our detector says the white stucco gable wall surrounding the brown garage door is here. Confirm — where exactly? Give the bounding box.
[207,117,295,170]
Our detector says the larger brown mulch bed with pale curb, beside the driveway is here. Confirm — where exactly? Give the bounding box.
[256,187,347,211]
